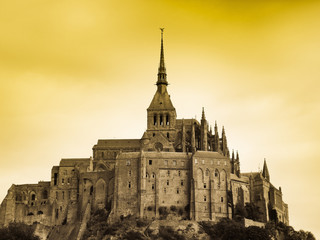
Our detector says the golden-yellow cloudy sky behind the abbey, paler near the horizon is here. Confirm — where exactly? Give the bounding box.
[0,0,320,238]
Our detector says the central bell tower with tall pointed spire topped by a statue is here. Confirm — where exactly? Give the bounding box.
[147,28,177,141]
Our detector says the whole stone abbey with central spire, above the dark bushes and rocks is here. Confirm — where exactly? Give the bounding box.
[0,30,289,231]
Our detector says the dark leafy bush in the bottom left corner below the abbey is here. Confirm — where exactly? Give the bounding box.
[0,223,40,240]
